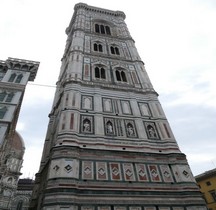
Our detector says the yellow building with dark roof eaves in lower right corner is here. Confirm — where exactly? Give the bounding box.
[195,169,216,210]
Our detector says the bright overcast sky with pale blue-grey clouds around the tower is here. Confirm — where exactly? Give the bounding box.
[0,0,216,178]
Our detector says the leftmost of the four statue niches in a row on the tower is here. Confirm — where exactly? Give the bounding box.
[80,115,94,134]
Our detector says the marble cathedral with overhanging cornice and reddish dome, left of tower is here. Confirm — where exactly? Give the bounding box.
[0,58,39,210]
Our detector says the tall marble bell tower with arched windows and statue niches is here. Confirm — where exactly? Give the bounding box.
[31,3,206,210]
